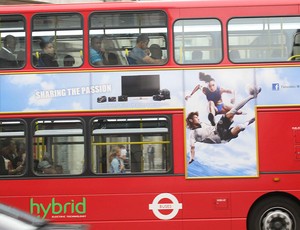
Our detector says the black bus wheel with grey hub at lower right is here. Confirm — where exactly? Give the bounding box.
[247,196,300,230]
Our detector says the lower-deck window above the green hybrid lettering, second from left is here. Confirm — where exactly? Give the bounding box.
[33,119,85,175]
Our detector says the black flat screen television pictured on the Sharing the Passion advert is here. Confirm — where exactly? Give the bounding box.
[122,75,160,97]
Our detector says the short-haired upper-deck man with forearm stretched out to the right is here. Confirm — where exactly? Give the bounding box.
[127,34,166,65]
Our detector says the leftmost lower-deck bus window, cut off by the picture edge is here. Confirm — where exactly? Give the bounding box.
[0,121,26,176]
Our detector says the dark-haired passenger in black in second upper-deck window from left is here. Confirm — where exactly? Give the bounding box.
[37,40,58,67]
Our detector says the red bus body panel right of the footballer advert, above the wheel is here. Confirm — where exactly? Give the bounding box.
[258,107,300,172]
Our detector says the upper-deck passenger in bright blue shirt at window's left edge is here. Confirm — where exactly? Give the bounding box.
[90,36,105,66]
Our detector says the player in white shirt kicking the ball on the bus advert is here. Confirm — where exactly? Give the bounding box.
[186,87,261,164]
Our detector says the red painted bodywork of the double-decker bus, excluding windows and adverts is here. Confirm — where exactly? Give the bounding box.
[0,0,300,230]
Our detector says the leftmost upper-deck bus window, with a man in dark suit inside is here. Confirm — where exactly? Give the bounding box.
[0,15,26,69]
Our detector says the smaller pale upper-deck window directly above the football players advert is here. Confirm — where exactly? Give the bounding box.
[174,19,222,64]
